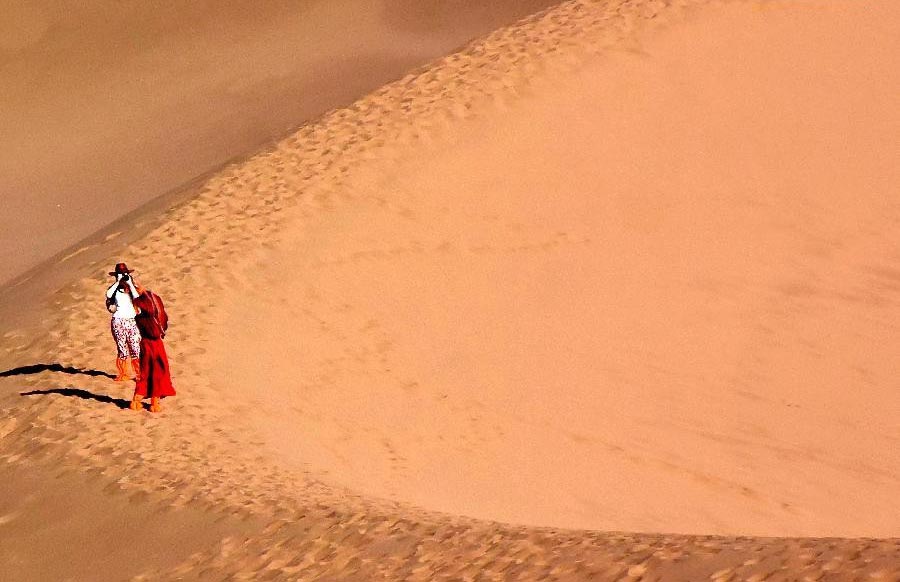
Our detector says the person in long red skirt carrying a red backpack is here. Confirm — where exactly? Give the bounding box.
[130,282,175,412]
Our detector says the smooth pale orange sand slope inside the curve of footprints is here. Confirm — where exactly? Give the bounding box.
[213,3,900,536]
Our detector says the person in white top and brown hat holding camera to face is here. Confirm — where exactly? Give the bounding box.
[106,263,141,382]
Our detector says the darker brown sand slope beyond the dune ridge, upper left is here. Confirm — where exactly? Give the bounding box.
[0,0,555,284]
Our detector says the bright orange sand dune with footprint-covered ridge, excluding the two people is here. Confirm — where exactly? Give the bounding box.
[0,0,900,581]
